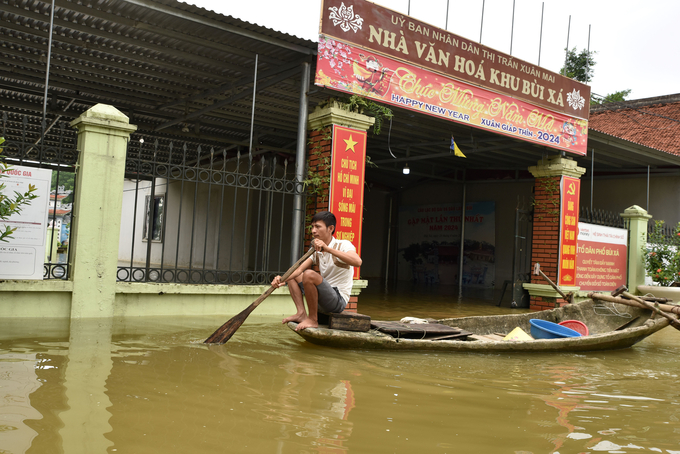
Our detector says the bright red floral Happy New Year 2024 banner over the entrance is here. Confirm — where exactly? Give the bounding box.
[314,36,588,156]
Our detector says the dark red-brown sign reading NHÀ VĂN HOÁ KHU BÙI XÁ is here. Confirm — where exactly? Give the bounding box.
[320,0,590,120]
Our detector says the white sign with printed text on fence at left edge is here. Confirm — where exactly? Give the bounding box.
[0,166,52,279]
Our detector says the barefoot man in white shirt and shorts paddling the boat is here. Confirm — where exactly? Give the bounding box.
[272,211,361,331]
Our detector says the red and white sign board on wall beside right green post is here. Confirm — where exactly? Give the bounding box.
[575,222,628,292]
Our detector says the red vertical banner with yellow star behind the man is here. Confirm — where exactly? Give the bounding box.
[330,125,366,279]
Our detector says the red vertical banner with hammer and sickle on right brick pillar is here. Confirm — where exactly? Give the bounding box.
[557,176,581,285]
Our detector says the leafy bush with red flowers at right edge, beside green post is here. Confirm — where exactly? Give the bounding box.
[643,221,680,286]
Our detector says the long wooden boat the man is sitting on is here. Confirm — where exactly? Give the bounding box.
[288,300,669,352]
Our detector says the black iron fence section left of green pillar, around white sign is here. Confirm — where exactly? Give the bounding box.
[0,112,78,279]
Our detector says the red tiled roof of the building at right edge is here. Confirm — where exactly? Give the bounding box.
[588,94,680,155]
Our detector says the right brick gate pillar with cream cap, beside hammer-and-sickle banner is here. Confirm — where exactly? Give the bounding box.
[524,155,586,310]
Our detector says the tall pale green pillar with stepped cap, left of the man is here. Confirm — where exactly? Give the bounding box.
[71,104,137,318]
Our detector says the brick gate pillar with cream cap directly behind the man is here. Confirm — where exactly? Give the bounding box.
[305,103,375,312]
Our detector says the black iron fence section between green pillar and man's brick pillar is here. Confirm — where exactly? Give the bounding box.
[117,134,302,284]
